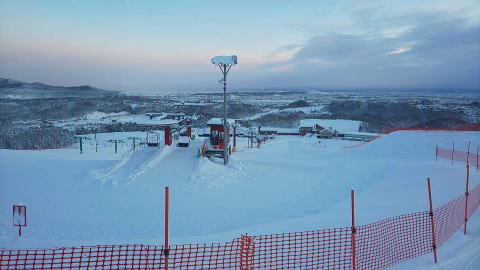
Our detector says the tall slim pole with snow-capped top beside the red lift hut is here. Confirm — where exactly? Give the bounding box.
[212,55,237,165]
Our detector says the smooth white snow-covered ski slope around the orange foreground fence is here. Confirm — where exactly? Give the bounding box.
[0,131,480,269]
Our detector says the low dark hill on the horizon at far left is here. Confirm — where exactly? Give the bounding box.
[0,78,120,99]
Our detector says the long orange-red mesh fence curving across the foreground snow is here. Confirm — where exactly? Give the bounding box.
[0,182,480,270]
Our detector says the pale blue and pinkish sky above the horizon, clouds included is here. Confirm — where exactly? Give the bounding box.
[0,0,480,93]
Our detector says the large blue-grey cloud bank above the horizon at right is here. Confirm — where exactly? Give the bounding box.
[271,15,480,89]
